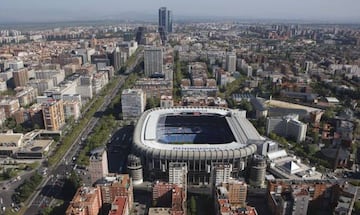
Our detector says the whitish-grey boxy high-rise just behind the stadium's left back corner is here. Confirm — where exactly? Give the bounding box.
[121,89,146,120]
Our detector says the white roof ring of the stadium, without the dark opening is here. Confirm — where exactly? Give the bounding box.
[140,107,263,151]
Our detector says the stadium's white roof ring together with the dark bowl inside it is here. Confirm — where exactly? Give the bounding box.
[140,107,263,150]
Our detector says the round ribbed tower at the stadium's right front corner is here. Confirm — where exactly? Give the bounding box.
[249,155,266,187]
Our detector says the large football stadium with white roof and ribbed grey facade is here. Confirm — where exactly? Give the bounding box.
[133,107,263,184]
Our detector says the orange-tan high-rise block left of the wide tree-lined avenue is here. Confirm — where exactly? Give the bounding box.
[41,100,65,131]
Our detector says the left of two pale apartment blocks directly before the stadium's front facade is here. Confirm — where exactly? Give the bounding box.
[169,162,187,188]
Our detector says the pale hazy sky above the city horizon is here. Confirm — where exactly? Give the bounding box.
[0,0,360,22]
